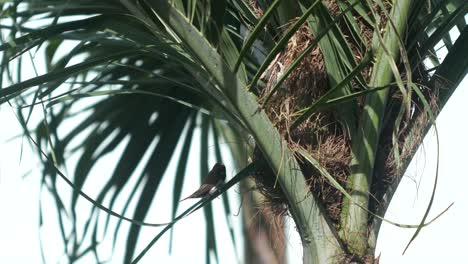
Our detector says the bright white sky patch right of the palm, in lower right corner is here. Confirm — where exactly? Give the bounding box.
[377,74,468,263]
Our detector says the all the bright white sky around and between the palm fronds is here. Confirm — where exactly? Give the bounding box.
[0,17,468,264]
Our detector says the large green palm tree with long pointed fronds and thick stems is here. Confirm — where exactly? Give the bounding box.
[0,0,468,263]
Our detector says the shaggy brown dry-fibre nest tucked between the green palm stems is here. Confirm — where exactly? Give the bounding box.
[254,18,356,223]
